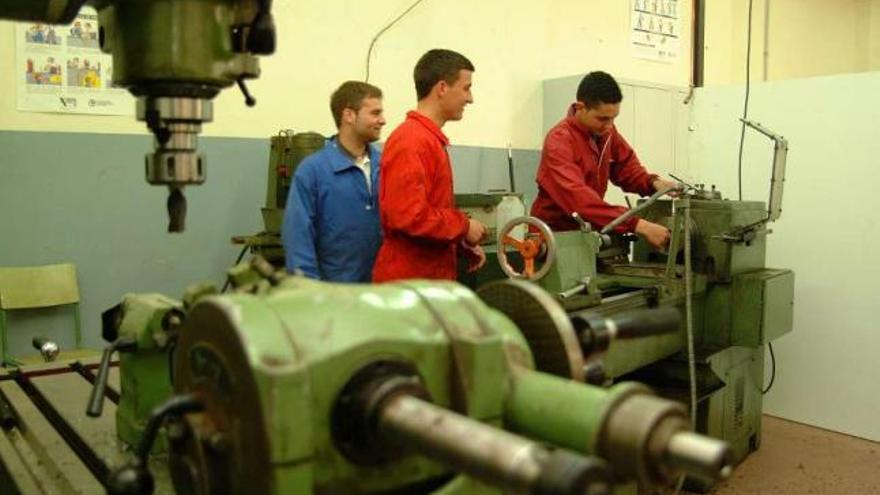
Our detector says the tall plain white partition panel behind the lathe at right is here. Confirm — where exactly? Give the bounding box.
[691,72,880,440]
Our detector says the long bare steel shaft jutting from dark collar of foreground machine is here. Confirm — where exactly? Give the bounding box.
[379,394,611,494]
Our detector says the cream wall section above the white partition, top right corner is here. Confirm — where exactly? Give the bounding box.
[705,0,880,86]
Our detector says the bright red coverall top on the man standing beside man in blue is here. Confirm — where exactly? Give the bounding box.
[373,112,468,282]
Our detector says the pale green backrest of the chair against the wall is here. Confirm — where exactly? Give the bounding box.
[0,263,79,310]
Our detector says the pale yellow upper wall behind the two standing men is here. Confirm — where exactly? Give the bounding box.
[0,0,691,148]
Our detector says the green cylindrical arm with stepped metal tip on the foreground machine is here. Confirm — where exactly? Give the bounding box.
[506,370,732,484]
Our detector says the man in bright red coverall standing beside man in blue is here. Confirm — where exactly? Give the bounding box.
[373,49,486,282]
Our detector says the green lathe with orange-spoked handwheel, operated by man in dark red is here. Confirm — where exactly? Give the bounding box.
[475,183,794,488]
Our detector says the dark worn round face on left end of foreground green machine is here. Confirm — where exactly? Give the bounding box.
[169,304,273,494]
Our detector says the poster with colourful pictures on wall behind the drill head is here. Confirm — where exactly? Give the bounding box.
[15,7,135,115]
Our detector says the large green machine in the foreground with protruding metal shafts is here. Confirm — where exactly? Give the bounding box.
[0,261,731,495]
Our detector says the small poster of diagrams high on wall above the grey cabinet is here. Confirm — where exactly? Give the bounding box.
[631,0,681,62]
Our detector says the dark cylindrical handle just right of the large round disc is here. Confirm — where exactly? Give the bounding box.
[571,306,681,356]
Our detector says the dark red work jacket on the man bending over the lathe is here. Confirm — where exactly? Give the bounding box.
[531,105,657,233]
